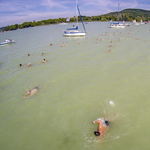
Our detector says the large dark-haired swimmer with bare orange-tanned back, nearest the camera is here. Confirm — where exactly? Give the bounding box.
[93,118,109,138]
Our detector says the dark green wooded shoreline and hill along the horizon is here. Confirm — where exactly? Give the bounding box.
[2,9,150,31]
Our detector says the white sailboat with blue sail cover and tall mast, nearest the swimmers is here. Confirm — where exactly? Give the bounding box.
[64,0,86,37]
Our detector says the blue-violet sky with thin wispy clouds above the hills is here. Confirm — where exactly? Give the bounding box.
[0,0,150,27]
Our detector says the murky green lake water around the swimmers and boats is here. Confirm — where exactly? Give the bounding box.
[0,22,150,150]
